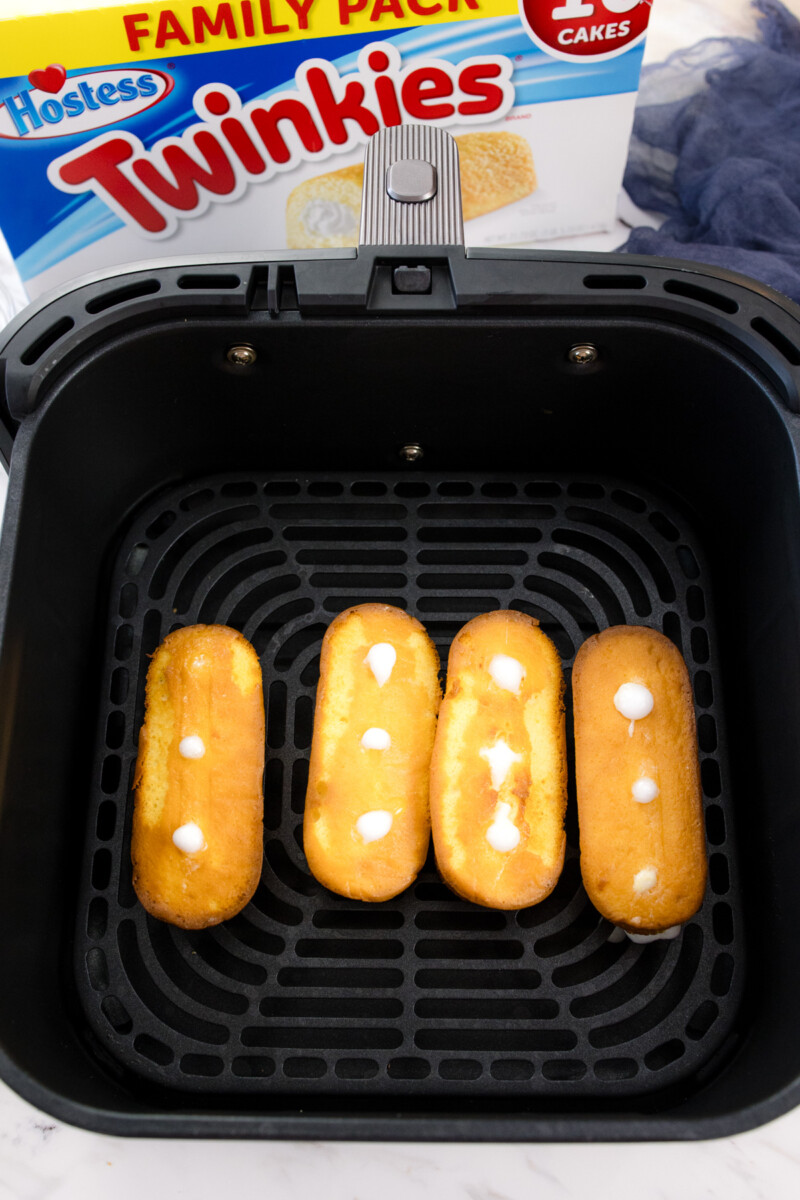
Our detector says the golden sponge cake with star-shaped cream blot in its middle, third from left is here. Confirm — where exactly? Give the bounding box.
[431,611,566,908]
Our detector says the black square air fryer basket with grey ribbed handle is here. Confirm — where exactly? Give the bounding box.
[0,130,800,1141]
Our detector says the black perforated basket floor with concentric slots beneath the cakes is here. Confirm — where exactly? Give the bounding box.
[76,470,744,1103]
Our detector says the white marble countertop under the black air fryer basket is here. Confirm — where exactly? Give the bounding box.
[0,0,800,1200]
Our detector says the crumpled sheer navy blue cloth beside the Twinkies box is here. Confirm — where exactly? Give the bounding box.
[622,0,800,301]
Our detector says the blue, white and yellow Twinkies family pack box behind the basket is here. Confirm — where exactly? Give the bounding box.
[0,0,650,296]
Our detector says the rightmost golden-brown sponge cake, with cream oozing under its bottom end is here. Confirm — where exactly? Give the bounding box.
[572,625,706,935]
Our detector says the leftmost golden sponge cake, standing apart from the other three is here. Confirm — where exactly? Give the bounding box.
[131,625,264,929]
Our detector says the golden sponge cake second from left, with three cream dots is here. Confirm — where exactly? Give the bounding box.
[303,604,441,901]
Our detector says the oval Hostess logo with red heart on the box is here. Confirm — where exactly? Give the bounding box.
[0,64,174,142]
